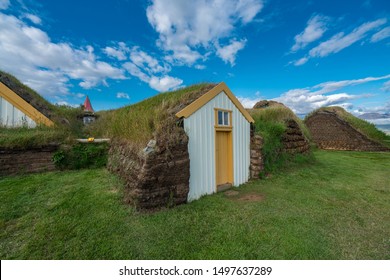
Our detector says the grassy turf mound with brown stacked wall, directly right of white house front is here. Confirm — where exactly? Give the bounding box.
[248,100,310,172]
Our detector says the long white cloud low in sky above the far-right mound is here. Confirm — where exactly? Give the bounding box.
[275,75,390,114]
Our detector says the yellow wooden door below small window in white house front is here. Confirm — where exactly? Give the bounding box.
[215,131,233,186]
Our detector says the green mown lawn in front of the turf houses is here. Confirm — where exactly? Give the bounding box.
[0,151,390,259]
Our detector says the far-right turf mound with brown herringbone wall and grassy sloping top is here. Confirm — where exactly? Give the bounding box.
[305,107,390,151]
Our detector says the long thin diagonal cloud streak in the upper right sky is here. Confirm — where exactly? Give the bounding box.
[309,18,387,57]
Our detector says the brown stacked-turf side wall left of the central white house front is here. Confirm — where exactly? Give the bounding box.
[108,129,190,210]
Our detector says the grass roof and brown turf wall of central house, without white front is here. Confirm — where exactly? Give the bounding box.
[90,84,214,210]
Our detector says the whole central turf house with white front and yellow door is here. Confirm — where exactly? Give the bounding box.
[100,83,254,209]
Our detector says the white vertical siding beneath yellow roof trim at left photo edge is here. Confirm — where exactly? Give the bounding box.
[0,97,36,128]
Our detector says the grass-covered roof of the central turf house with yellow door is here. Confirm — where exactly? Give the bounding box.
[89,83,214,148]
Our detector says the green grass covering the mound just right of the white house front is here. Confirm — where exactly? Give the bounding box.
[248,103,310,173]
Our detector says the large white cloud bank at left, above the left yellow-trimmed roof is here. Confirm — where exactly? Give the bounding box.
[0,13,125,96]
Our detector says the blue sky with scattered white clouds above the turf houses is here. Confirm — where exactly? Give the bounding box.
[0,0,390,123]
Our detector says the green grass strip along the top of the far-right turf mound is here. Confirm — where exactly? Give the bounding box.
[305,106,390,148]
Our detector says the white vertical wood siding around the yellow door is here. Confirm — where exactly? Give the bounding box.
[184,92,250,201]
